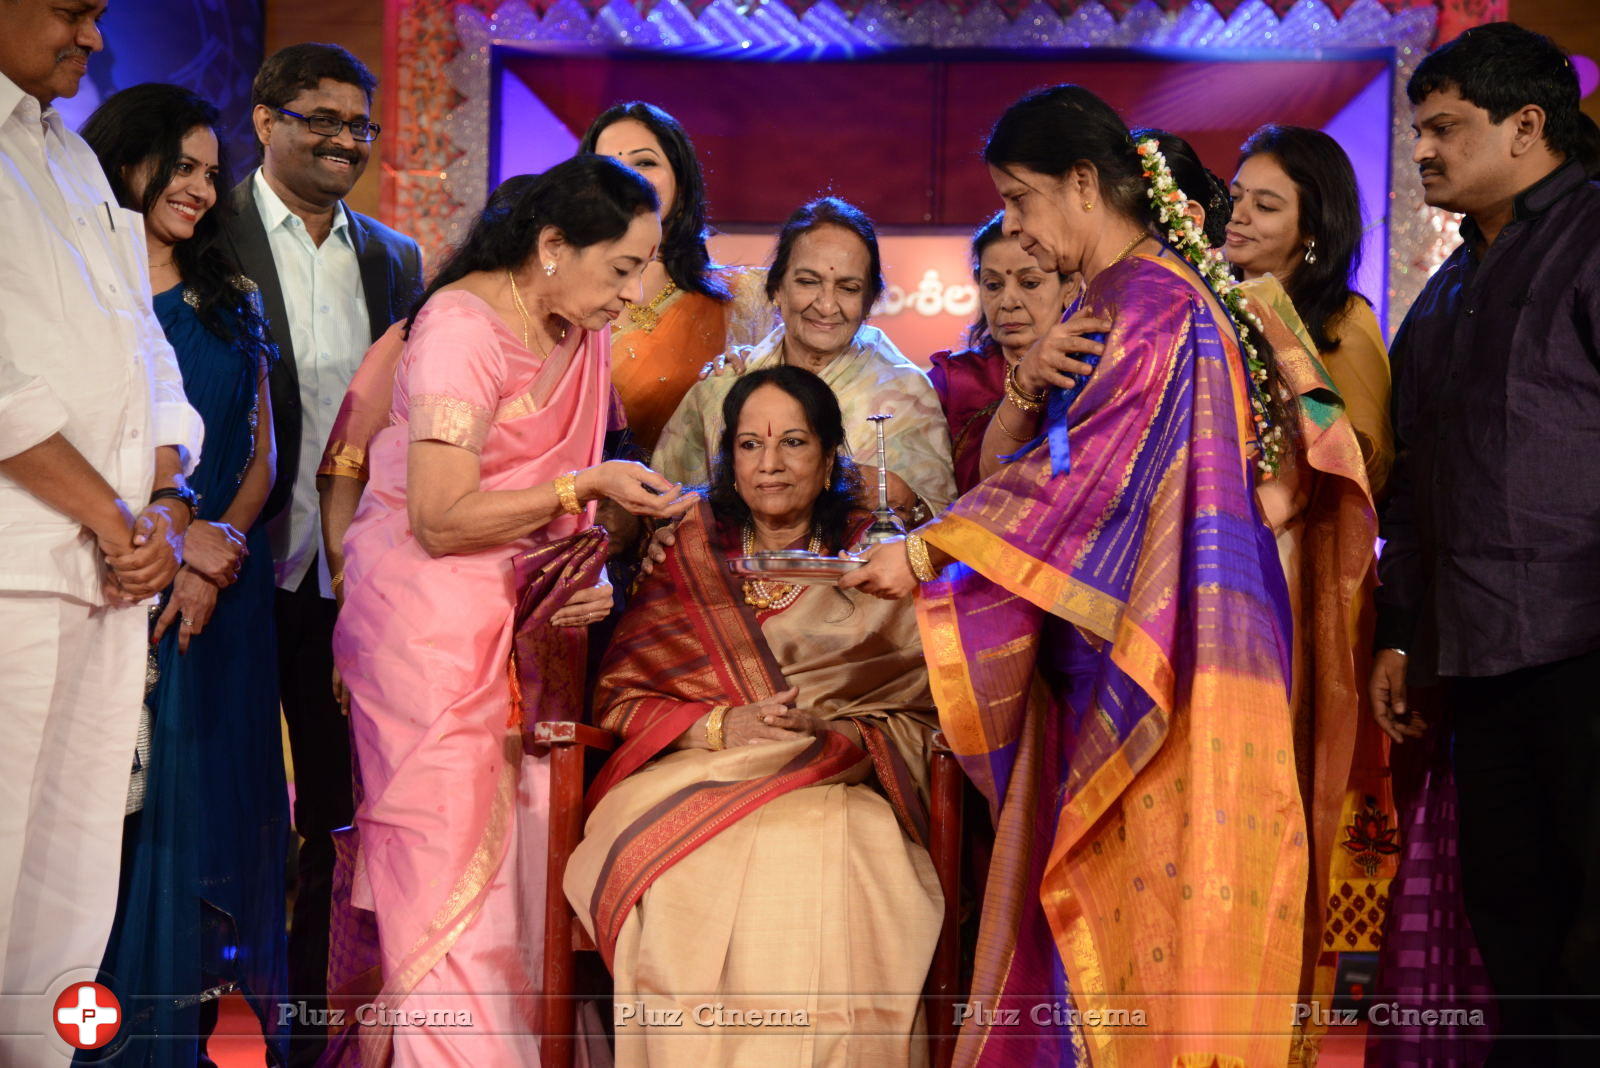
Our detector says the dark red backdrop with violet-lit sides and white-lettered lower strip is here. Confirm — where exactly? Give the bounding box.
[488,45,1392,361]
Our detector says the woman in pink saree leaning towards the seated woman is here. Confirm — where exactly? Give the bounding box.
[334,157,693,1068]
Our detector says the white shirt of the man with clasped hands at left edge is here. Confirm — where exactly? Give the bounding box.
[0,75,205,604]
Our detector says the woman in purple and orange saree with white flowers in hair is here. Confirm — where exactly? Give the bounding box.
[842,86,1309,1068]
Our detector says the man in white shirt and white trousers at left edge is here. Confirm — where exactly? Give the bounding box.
[0,0,203,1048]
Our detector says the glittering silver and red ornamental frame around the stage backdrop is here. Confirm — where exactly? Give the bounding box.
[382,0,1507,342]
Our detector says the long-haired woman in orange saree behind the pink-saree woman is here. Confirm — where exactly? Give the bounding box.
[579,101,776,459]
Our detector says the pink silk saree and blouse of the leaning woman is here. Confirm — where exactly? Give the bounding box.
[334,291,610,1068]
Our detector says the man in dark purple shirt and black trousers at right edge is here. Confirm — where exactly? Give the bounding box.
[1373,22,1600,1065]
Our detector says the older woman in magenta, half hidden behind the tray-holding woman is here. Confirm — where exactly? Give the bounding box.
[928,214,1078,494]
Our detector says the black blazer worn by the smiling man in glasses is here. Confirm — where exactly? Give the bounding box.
[222,173,422,520]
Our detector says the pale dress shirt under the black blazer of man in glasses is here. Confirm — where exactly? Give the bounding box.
[251,169,371,596]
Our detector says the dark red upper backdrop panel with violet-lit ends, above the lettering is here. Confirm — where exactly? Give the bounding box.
[491,48,1387,227]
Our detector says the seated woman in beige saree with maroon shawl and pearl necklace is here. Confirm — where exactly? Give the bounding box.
[566,366,942,1068]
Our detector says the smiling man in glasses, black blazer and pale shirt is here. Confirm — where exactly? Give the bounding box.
[219,43,422,1065]
